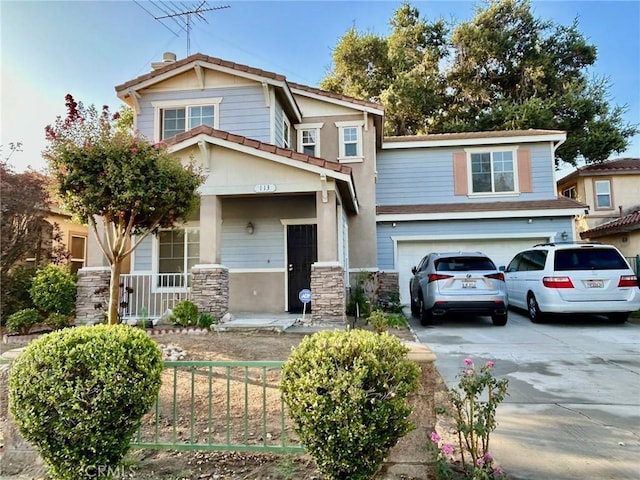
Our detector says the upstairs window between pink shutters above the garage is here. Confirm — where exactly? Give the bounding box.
[469,150,517,193]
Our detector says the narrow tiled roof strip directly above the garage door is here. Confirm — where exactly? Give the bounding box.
[376,197,588,215]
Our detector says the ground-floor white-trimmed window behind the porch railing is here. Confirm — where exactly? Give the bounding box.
[156,228,200,287]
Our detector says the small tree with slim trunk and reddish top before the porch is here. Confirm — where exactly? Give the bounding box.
[45,95,203,324]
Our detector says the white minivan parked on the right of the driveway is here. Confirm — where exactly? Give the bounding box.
[504,243,640,323]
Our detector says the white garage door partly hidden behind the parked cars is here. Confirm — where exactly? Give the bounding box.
[396,237,549,305]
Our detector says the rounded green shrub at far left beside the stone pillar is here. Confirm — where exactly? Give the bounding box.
[29,265,77,315]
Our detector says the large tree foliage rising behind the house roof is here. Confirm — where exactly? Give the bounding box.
[321,0,638,165]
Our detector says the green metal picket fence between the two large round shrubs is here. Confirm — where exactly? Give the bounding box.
[131,361,304,452]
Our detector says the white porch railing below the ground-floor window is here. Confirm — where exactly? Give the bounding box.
[118,273,191,321]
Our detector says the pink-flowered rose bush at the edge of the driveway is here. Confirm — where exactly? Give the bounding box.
[431,358,509,480]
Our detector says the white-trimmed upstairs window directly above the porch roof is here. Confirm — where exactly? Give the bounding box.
[152,98,222,140]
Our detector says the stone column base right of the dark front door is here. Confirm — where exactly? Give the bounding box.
[311,262,346,323]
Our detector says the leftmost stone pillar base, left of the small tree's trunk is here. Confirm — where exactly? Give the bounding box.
[76,267,111,325]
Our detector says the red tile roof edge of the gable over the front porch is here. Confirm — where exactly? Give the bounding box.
[164,125,351,176]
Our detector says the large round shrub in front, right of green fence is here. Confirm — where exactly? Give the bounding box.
[280,330,419,480]
